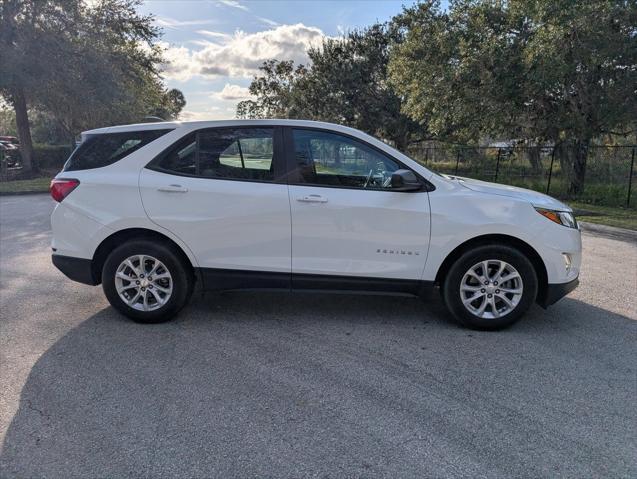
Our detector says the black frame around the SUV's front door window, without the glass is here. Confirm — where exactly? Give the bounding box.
[283,126,436,193]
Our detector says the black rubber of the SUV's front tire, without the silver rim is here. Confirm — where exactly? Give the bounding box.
[443,245,538,330]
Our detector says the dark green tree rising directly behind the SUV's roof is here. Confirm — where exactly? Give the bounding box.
[237,24,423,149]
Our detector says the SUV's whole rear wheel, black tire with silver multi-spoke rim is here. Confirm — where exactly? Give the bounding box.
[102,239,194,323]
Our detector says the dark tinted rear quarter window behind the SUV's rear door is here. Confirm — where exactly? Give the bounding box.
[64,129,172,171]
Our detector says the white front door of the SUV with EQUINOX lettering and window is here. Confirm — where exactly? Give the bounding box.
[285,128,430,289]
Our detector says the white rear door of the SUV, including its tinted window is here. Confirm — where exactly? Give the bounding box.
[140,127,291,289]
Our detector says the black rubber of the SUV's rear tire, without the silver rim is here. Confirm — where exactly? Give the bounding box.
[102,240,193,323]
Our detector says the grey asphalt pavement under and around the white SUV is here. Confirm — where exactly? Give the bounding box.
[0,195,637,478]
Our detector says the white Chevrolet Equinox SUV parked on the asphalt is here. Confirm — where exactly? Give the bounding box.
[51,120,581,329]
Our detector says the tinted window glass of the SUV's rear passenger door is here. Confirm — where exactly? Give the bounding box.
[155,128,274,181]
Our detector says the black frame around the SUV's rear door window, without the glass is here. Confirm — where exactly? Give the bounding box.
[144,125,287,184]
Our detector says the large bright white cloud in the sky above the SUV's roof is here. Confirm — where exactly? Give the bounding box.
[159,23,325,81]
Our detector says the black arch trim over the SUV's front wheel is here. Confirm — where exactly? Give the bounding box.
[435,234,548,303]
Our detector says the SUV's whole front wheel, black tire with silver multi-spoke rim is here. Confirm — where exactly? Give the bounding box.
[442,245,538,331]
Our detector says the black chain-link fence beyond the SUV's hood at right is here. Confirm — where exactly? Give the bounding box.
[409,145,637,208]
